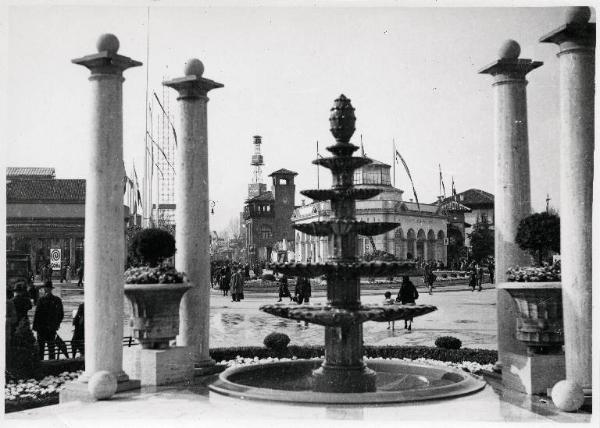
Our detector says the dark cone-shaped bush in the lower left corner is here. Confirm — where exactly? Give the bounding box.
[6,319,40,379]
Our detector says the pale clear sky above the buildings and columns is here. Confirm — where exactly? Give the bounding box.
[3,2,595,230]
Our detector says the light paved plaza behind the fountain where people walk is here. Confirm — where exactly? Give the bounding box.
[54,284,496,349]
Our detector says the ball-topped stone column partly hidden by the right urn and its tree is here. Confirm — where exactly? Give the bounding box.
[479,40,542,365]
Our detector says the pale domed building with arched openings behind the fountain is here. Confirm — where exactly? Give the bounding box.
[292,160,448,264]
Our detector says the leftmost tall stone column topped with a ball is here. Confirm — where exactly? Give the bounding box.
[61,34,142,401]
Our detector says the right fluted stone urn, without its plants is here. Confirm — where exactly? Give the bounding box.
[498,282,564,355]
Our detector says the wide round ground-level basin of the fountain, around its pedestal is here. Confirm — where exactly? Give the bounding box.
[210,359,485,404]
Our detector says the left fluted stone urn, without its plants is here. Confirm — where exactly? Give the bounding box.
[125,281,192,349]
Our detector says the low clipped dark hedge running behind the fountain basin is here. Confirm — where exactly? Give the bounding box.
[210,345,498,364]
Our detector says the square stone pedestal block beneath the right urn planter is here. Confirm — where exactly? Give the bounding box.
[502,352,566,394]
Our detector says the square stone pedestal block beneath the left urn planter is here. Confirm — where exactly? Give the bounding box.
[123,346,194,386]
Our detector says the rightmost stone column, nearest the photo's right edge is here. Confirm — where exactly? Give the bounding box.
[540,7,596,394]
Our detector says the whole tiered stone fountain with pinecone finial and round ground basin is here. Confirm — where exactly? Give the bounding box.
[211,95,484,403]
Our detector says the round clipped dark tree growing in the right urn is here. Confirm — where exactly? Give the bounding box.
[515,212,560,265]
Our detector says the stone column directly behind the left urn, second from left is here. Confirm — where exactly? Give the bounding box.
[163,59,223,368]
